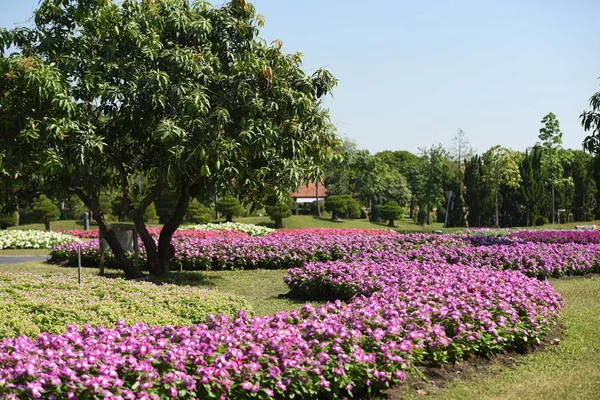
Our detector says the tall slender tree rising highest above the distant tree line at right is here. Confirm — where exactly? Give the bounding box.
[538,113,572,224]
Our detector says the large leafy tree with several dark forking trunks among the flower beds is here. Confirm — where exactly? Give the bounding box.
[0,0,337,278]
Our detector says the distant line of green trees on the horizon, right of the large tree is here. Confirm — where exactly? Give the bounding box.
[323,113,600,227]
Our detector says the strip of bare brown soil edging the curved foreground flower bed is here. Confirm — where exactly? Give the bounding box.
[382,324,565,400]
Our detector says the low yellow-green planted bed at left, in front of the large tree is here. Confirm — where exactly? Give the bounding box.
[0,273,249,337]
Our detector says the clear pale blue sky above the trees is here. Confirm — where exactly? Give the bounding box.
[0,0,600,153]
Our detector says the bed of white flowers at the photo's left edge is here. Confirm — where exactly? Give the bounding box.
[0,230,80,250]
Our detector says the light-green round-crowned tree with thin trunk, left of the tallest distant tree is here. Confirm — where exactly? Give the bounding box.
[483,145,521,228]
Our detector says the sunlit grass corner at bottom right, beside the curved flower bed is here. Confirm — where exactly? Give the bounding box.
[400,277,600,400]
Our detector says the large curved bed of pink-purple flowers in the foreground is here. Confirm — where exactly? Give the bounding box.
[0,260,562,399]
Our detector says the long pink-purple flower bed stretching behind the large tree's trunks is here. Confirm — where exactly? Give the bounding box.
[51,231,600,279]
